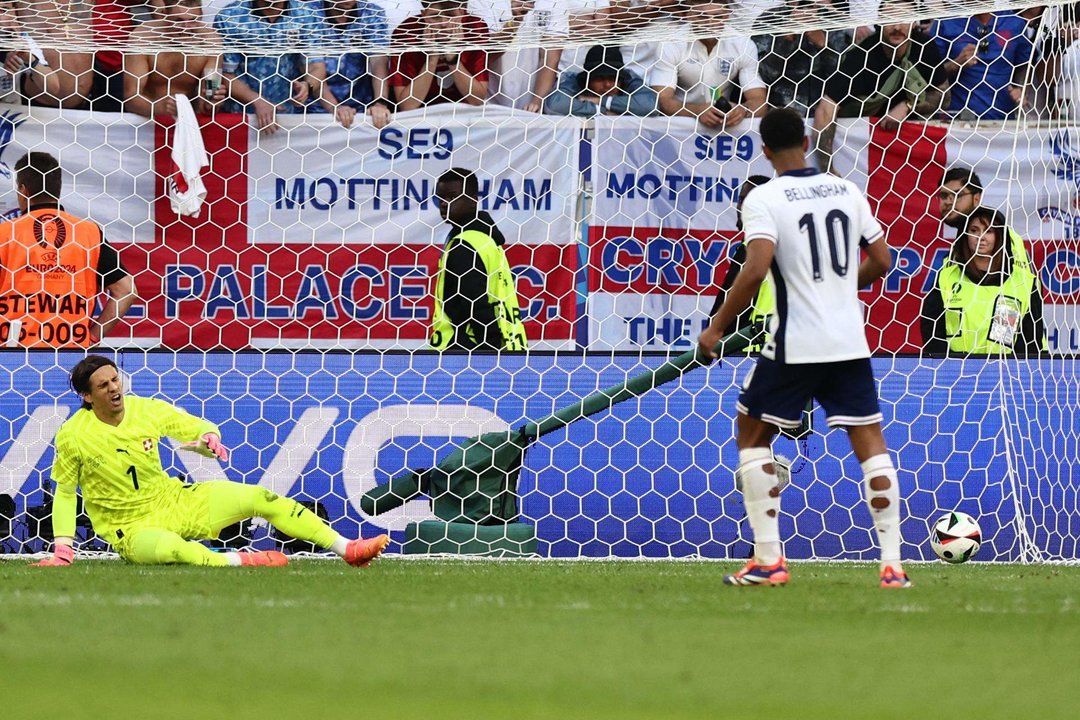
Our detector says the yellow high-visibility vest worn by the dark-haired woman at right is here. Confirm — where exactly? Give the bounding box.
[937,259,1045,355]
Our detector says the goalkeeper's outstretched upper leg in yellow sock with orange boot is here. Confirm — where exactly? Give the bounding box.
[200,480,390,566]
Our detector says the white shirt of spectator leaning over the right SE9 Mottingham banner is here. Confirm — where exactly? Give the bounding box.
[646,37,766,103]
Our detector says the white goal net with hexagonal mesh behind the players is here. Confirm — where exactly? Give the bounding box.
[0,0,1080,561]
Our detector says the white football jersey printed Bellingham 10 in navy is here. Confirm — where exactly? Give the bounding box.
[742,167,883,364]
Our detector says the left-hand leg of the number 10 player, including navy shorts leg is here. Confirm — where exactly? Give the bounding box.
[724,357,809,585]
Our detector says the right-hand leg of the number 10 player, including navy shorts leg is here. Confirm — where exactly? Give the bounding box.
[818,359,910,587]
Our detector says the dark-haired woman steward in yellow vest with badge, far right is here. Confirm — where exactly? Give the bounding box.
[921,207,1048,356]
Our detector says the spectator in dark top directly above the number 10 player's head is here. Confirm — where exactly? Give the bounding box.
[754,0,852,117]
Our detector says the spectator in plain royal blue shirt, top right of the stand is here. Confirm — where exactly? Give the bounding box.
[933,12,1032,120]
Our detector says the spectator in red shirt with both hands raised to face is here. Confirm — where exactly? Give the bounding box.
[389,0,488,110]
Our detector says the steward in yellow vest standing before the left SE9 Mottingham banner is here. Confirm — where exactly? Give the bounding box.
[430,168,528,352]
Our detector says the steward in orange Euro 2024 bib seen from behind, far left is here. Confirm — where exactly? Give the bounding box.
[0,152,135,349]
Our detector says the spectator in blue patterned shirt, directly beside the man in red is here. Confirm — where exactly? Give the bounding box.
[314,0,393,127]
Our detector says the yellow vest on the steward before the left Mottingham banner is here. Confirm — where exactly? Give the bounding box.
[430,230,528,351]
